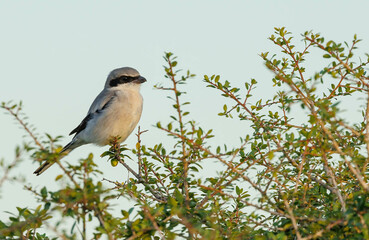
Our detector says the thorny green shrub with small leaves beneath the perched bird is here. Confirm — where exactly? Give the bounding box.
[0,28,369,239]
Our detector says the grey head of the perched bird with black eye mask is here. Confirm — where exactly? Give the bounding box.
[105,67,146,88]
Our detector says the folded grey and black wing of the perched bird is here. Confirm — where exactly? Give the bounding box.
[69,90,116,135]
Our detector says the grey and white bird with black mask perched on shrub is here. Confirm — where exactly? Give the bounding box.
[34,67,146,176]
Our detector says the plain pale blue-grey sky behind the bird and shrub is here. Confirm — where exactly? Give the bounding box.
[0,0,369,232]
